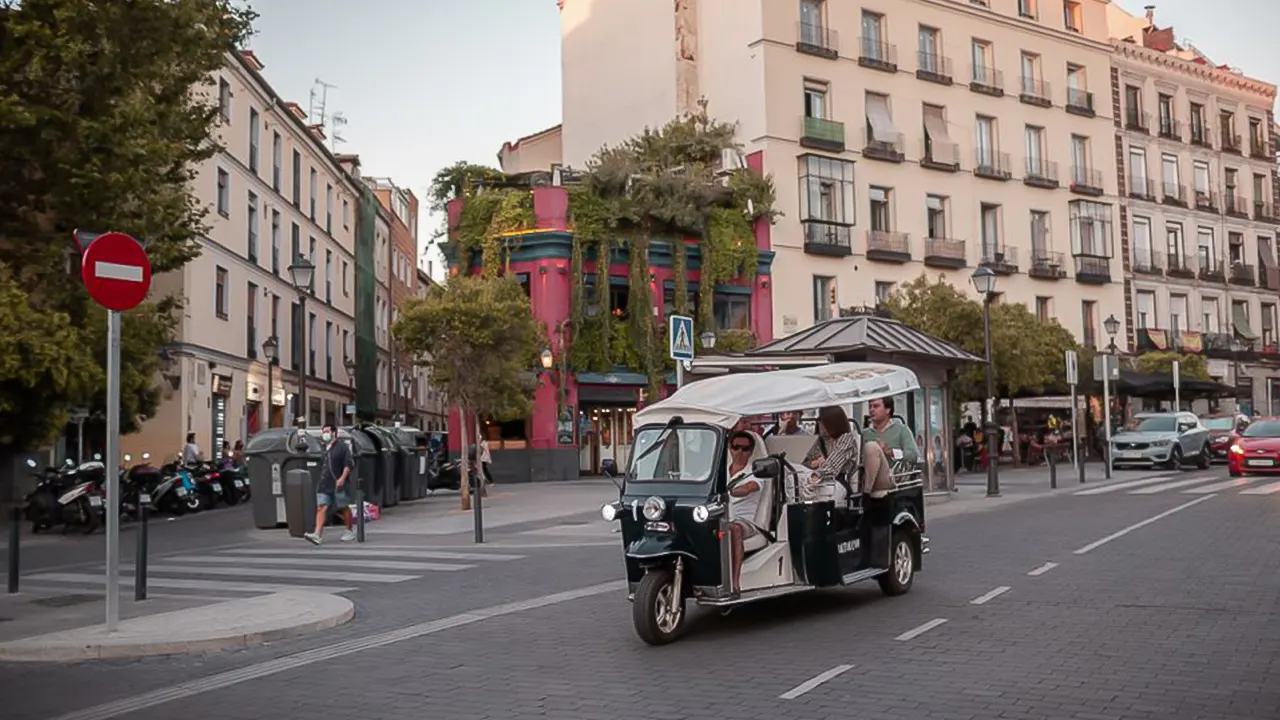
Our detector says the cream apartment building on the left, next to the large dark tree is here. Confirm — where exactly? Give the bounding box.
[122,51,358,456]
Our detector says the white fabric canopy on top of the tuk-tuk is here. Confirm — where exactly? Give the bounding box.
[635,363,920,428]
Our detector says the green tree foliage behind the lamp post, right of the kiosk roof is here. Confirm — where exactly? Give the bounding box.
[887,274,1083,400]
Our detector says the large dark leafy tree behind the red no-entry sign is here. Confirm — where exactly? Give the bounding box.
[0,0,253,446]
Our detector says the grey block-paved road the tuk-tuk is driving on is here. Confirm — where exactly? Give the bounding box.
[0,470,1280,720]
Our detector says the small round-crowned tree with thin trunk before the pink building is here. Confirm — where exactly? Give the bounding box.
[392,275,547,510]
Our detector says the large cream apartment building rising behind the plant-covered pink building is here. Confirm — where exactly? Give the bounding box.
[558,0,1124,345]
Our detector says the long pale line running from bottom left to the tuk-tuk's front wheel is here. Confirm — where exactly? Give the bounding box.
[41,579,626,720]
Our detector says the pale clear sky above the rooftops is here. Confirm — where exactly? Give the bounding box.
[250,0,1280,277]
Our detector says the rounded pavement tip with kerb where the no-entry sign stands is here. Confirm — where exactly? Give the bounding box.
[0,588,355,662]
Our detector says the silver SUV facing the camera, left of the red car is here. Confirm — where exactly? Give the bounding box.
[1111,413,1210,469]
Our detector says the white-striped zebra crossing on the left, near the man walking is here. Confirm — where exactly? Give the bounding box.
[23,541,525,598]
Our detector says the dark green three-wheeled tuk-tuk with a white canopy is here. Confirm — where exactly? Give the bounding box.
[600,363,929,646]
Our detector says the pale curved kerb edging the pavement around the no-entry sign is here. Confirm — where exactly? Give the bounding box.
[0,593,356,662]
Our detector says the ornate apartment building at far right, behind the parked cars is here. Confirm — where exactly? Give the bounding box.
[1108,8,1280,413]
